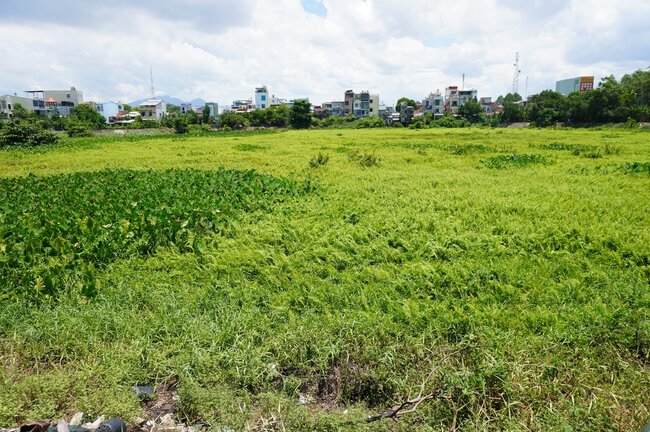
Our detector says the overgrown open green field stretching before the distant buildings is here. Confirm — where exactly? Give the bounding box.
[0,128,650,431]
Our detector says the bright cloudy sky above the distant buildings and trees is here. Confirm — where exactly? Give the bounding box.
[0,0,650,104]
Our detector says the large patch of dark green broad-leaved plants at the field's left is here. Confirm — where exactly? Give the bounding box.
[0,169,312,298]
